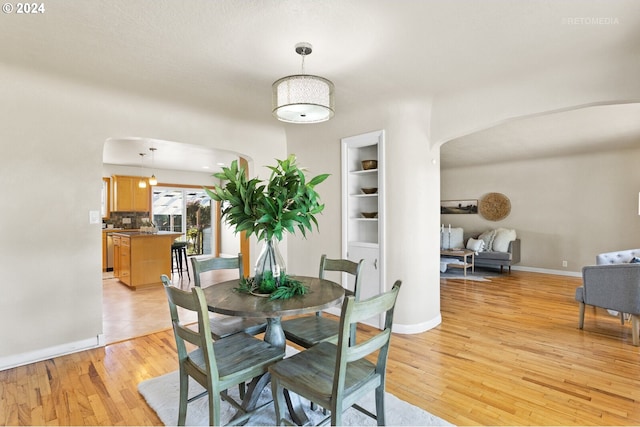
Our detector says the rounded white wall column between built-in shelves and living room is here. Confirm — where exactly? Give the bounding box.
[385,101,442,333]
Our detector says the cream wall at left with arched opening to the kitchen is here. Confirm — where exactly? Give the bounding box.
[0,66,286,369]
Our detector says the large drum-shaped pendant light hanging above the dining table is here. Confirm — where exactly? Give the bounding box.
[272,43,334,123]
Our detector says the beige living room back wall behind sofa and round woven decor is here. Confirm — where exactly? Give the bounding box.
[441,147,640,274]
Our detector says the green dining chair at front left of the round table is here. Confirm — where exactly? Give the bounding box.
[162,275,284,426]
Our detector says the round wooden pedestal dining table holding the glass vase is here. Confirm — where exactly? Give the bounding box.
[202,276,345,425]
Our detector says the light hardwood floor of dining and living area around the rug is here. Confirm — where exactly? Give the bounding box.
[0,271,640,425]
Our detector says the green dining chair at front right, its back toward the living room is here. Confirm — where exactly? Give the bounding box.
[269,280,401,426]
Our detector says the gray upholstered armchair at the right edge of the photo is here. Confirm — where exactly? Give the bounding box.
[575,260,640,346]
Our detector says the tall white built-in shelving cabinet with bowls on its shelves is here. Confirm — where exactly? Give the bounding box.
[341,131,385,327]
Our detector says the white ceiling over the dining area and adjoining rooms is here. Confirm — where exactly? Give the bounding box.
[0,0,640,171]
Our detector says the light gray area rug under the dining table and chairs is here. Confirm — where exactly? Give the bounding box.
[138,371,452,426]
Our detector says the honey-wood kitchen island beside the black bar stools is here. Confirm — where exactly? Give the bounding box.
[112,231,182,289]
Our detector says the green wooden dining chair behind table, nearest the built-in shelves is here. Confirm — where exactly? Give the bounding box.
[282,255,364,348]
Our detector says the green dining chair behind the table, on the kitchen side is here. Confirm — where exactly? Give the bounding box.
[191,254,267,340]
